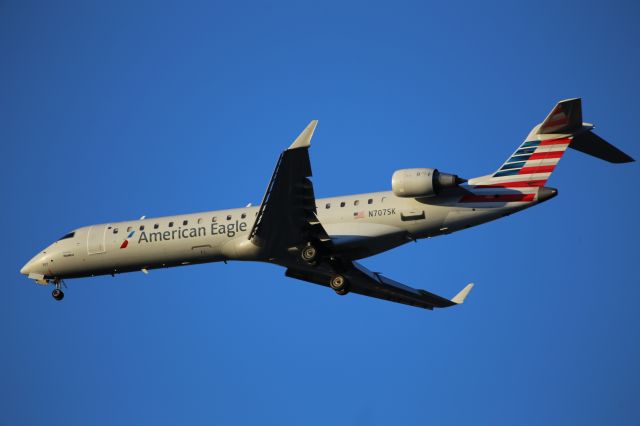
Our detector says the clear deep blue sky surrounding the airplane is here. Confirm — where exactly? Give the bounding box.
[0,1,640,426]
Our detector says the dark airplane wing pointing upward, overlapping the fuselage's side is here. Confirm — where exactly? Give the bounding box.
[249,120,331,257]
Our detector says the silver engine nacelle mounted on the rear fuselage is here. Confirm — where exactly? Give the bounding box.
[391,169,464,198]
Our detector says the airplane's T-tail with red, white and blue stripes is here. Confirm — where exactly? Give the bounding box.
[469,98,634,196]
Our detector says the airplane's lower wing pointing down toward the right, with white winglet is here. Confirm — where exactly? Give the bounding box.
[285,262,473,310]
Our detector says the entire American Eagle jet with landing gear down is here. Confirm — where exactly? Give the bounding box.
[20,99,634,309]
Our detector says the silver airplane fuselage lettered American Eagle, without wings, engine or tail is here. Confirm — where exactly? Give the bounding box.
[21,188,555,283]
